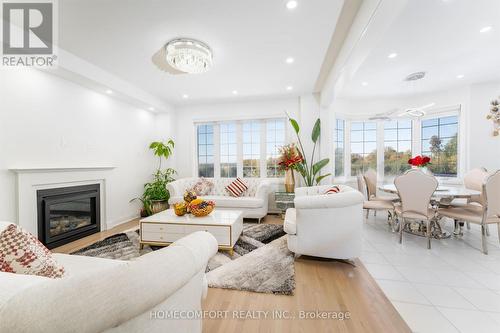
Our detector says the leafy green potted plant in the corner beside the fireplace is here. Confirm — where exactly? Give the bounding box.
[131,139,176,216]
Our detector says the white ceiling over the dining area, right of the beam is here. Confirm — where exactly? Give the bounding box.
[337,0,500,98]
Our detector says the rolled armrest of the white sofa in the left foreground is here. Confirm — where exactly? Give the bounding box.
[0,231,217,333]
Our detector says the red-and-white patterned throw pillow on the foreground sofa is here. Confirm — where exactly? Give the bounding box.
[0,224,64,278]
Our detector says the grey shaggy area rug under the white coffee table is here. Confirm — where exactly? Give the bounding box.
[72,223,295,295]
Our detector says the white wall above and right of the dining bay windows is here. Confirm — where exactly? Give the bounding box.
[329,82,500,175]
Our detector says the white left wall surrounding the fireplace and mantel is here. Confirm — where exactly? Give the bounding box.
[0,68,173,227]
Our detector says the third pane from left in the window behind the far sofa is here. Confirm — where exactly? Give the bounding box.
[243,121,261,177]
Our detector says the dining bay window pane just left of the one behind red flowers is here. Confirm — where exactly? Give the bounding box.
[384,120,412,175]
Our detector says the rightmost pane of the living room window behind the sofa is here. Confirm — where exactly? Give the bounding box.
[266,119,285,177]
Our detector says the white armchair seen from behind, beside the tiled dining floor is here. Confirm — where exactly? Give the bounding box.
[284,185,364,259]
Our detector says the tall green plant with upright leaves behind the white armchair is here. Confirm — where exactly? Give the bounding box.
[287,114,331,186]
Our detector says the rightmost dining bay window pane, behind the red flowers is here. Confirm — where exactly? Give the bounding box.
[422,116,458,177]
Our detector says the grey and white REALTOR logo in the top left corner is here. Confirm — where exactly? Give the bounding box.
[1,0,56,67]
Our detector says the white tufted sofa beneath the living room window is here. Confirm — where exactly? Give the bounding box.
[167,178,270,222]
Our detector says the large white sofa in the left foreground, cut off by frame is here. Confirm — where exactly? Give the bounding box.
[0,227,217,333]
